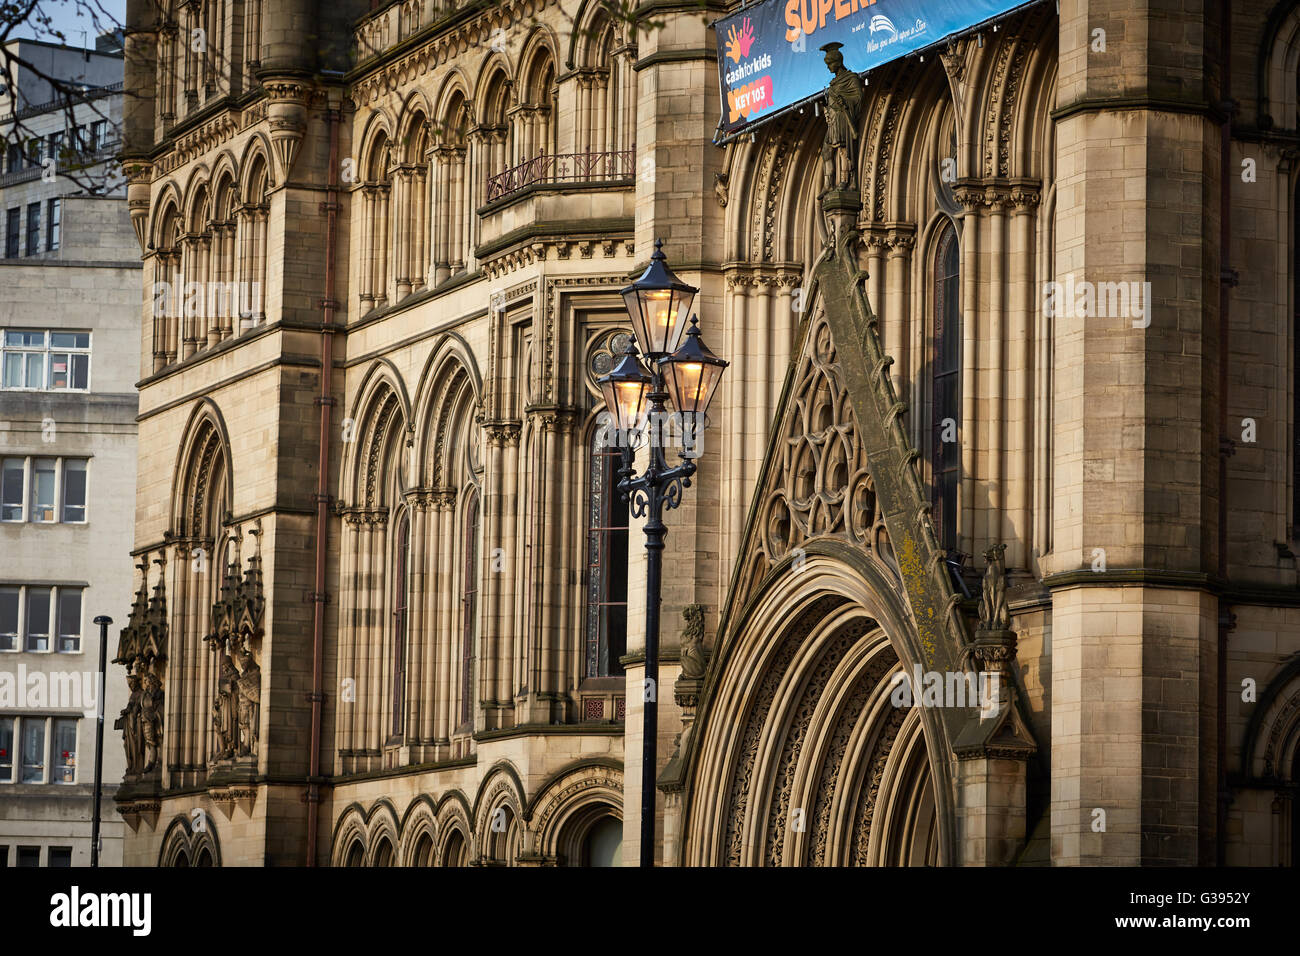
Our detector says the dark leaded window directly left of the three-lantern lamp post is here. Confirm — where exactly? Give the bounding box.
[585,428,628,678]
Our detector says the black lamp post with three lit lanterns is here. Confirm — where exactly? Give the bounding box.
[599,239,728,866]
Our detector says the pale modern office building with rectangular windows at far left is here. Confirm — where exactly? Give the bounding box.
[0,40,140,866]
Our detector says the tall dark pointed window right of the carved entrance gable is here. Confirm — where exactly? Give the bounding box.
[931,224,962,550]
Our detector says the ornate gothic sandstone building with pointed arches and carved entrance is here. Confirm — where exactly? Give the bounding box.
[117,0,1300,866]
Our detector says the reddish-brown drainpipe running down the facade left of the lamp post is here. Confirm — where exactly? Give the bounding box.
[307,87,342,866]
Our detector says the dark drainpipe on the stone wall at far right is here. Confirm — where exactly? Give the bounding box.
[1214,4,1236,866]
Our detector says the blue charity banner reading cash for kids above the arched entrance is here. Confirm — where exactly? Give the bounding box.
[714,0,1030,134]
